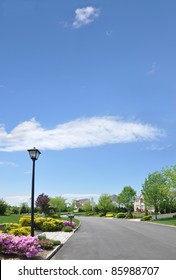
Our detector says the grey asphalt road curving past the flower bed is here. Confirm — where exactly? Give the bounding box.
[52,217,176,260]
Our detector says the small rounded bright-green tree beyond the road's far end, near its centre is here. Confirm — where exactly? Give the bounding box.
[97,194,115,214]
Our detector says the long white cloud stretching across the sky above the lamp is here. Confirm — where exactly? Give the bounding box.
[0,116,166,152]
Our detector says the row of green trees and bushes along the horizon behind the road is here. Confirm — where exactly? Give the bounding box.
[0,165,176,218]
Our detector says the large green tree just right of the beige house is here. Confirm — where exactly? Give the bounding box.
[142,171,168,219]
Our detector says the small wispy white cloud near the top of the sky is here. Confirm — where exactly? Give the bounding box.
[73,6,100,28]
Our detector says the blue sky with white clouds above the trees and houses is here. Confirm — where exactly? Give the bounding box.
[0,0,176,204]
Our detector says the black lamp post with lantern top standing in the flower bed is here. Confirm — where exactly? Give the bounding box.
[28,147,41,236]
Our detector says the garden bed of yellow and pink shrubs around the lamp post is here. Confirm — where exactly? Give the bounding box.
[0,216,79,259]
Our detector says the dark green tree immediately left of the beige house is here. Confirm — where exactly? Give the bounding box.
[118,186,136,212]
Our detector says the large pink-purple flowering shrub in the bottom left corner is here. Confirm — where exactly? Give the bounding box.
[0,233,42,258]
